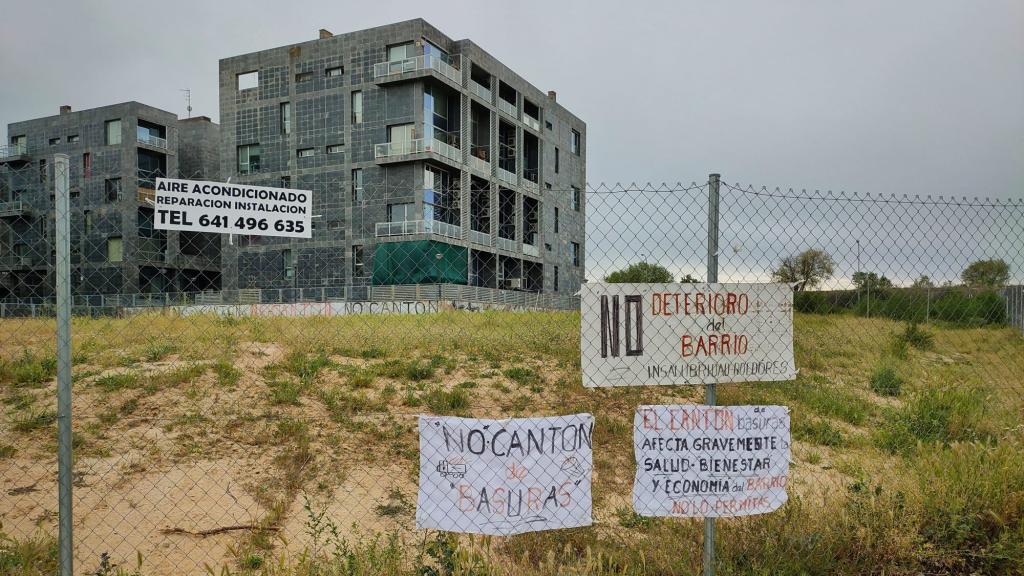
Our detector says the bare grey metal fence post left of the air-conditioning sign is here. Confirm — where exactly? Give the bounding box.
[53,154,73,576]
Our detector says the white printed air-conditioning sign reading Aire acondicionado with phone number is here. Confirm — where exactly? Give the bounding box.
[154,178,312,238]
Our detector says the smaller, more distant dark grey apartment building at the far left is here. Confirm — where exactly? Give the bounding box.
[0,101,221,298]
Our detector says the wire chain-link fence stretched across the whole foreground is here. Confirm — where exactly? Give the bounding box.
[0,161,1024,575]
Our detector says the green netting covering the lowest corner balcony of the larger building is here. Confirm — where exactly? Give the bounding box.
[374,240,469,286]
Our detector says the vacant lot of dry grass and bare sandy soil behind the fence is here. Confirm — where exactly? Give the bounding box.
[0,312,1024,575]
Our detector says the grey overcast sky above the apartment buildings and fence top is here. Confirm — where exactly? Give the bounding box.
[0,0,1024,198]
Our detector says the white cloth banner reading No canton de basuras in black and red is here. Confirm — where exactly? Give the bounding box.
[416,414,594,535]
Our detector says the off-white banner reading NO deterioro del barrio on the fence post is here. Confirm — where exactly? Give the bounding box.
[580,283,797,387]
